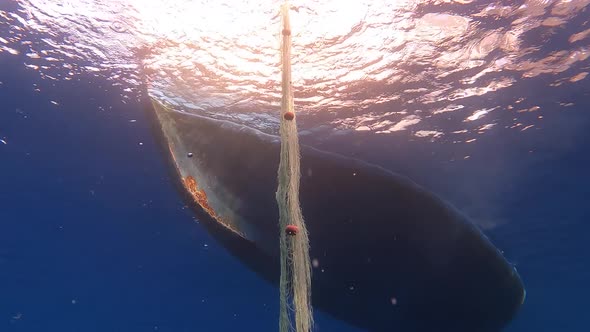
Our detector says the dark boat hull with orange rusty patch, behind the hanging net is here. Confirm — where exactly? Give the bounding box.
[152,101,524,332]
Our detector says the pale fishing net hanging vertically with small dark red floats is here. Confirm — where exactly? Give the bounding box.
[276,2,313,332]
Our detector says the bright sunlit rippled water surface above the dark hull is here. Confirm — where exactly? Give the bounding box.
[0,0,590,132]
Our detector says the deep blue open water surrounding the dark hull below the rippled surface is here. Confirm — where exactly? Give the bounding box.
[0,0,590,332]
